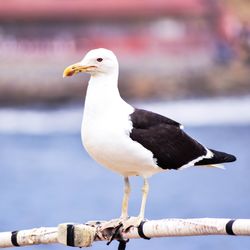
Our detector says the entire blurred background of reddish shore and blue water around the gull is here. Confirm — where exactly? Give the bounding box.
[0,0,250,250]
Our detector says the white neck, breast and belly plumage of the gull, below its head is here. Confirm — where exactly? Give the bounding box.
[81,78,162,177]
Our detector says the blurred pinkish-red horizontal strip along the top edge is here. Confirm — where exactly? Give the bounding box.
[0,0,208,20]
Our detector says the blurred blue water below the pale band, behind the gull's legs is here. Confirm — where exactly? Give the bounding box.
[0,125,250,250]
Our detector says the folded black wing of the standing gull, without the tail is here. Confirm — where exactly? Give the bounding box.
[130,109,207,169]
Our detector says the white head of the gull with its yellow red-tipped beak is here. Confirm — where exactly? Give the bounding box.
[63,48,118,77]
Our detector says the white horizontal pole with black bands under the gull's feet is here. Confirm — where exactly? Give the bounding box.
[0,218,250,248]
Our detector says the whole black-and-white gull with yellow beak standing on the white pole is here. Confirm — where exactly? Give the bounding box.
[63,48,236,228]
